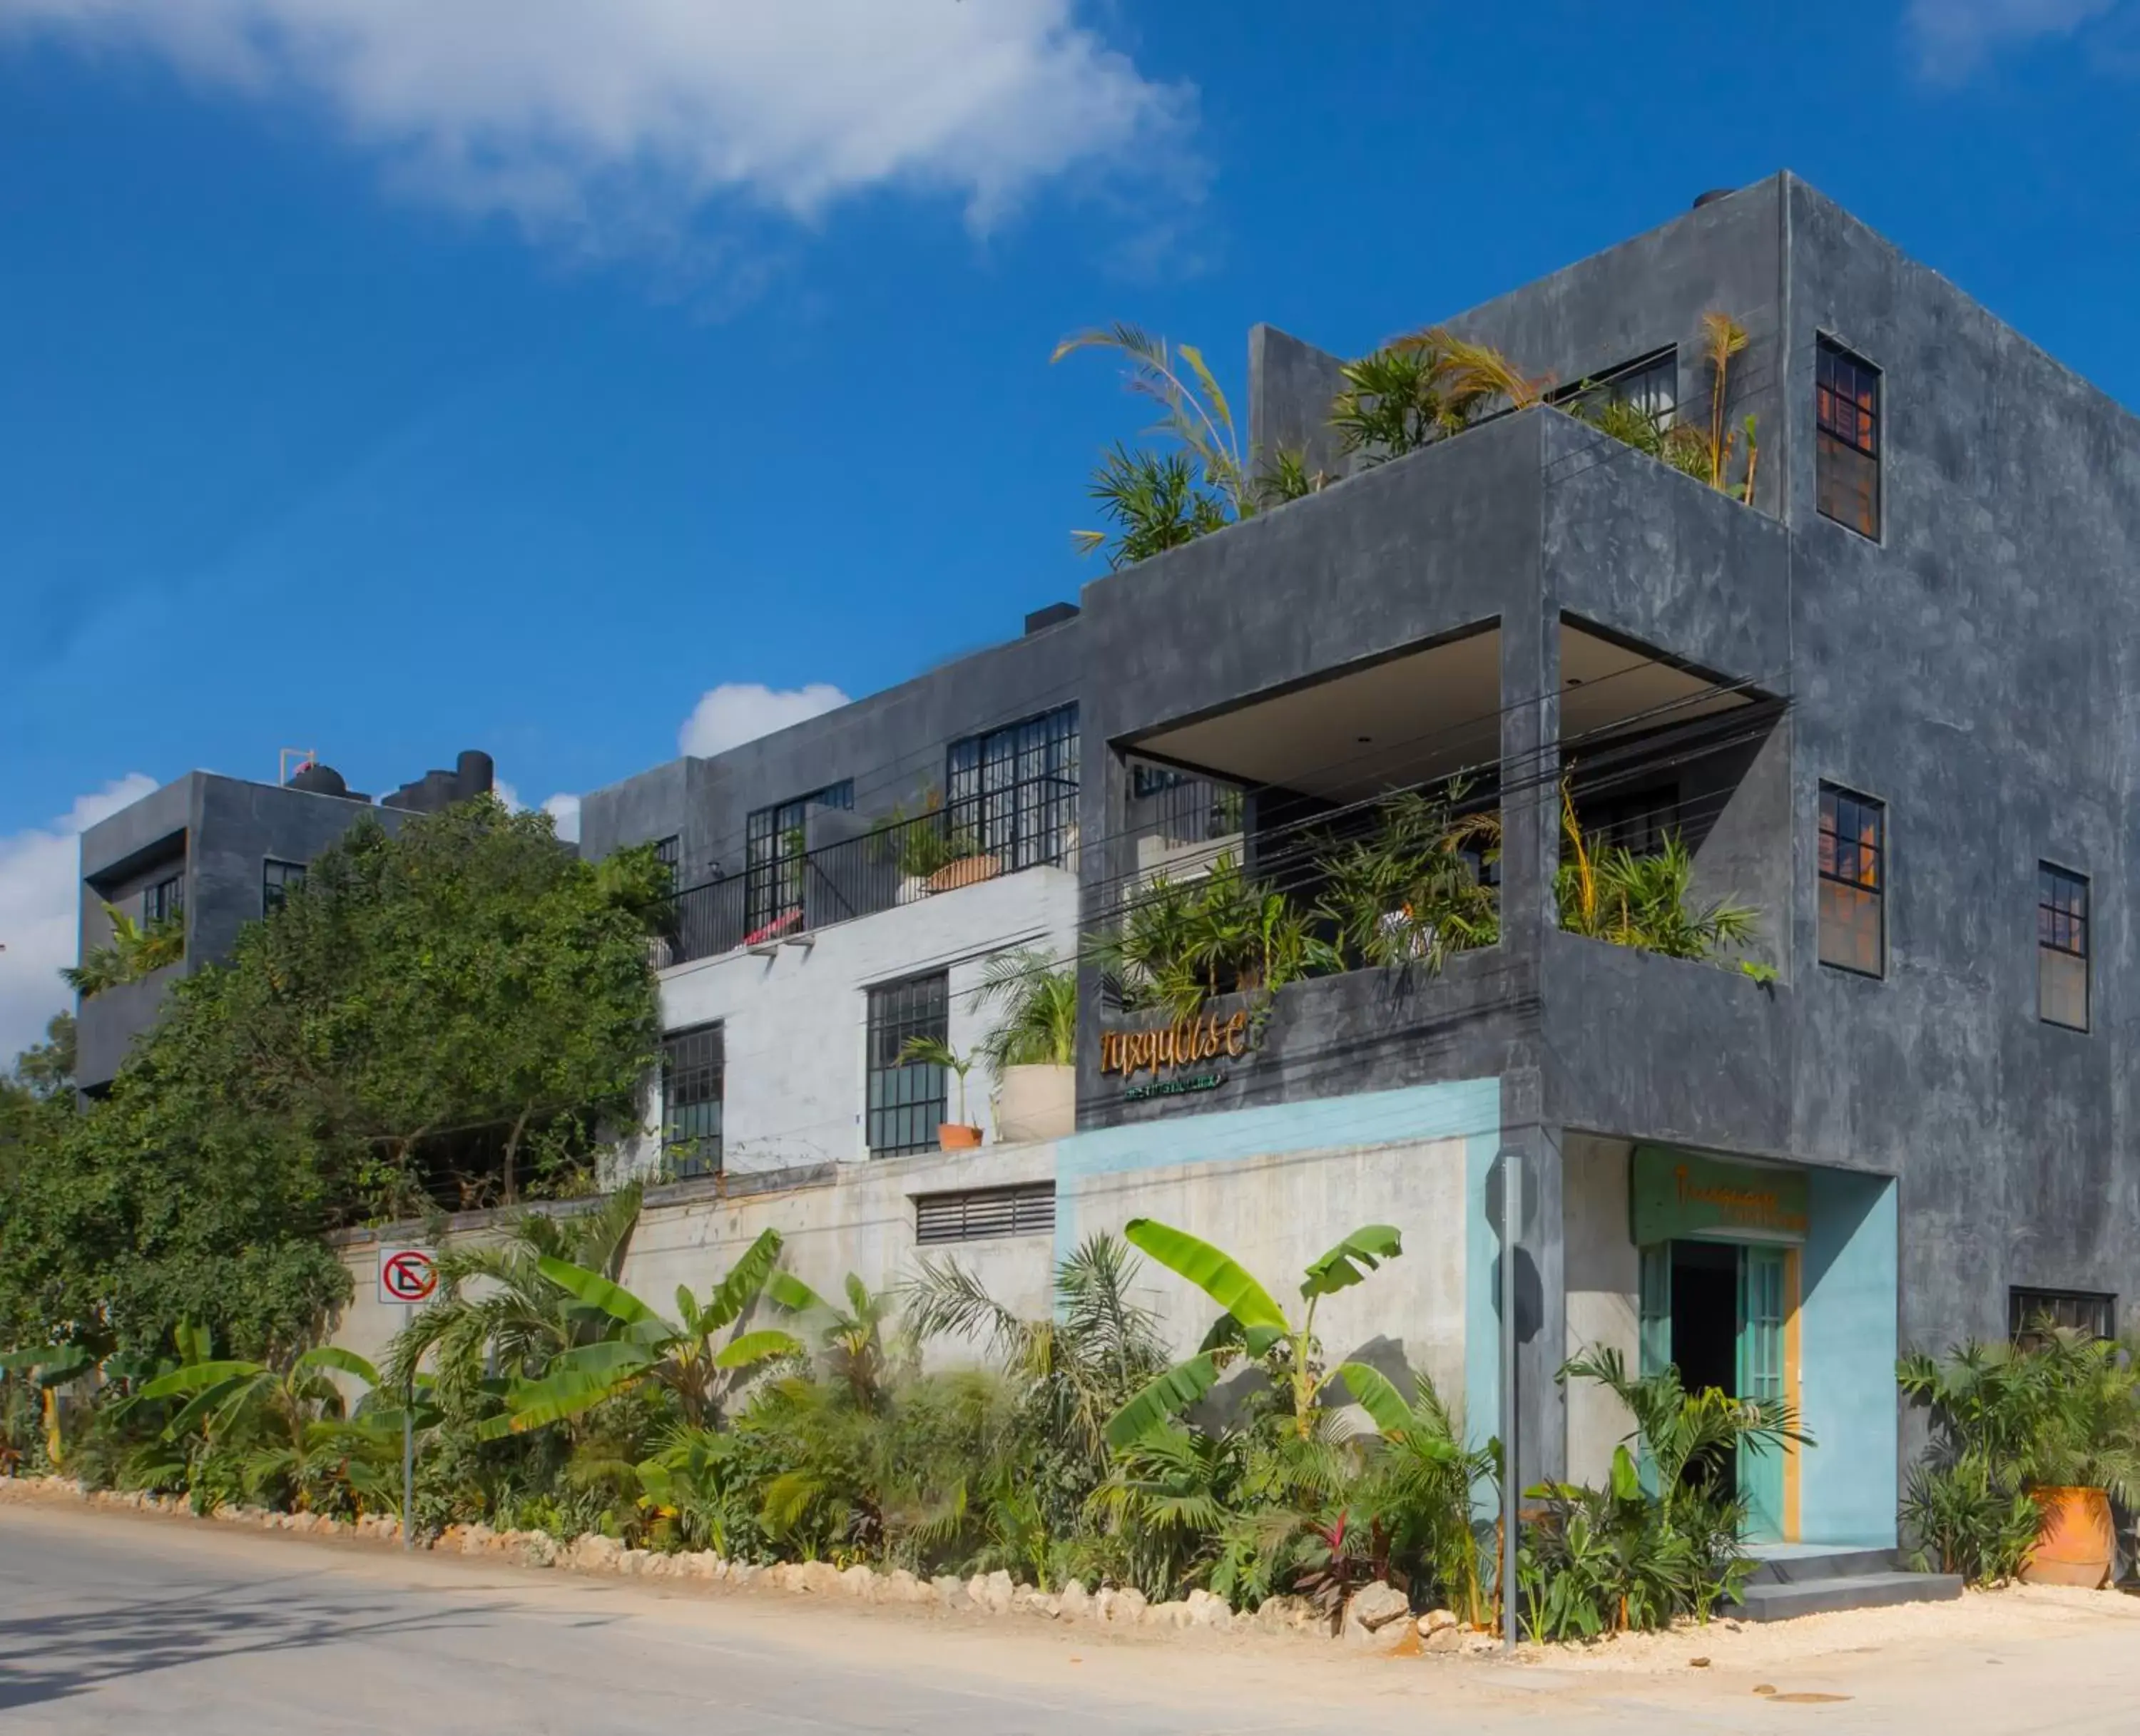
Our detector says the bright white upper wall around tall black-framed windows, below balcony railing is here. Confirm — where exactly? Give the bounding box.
[625,867,1076,1175]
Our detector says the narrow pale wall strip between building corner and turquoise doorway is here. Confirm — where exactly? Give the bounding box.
[1560,1133,1641,1488]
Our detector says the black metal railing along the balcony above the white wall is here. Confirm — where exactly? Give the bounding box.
[653,811,1076,970]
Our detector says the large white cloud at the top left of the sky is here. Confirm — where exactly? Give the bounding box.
[0,0,1194,261]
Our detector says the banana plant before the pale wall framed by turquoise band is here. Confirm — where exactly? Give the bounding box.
[1106,1218,1410,1451]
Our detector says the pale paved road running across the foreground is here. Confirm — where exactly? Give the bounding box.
[0,1505,2140,1736]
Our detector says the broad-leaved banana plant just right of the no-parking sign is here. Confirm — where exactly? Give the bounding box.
[475,1229,805,1441]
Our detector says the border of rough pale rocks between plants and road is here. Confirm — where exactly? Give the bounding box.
[0,1477,1500,1655]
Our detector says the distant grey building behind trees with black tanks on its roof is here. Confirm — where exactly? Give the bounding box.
[75,751,492,1092]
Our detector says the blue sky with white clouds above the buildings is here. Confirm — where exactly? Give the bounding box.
[0,0,2140,1053]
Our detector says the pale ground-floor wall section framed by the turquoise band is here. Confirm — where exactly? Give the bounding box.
[1064,1139,1466,1406]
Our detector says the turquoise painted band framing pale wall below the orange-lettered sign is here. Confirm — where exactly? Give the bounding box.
[1055,1079,1500,1441]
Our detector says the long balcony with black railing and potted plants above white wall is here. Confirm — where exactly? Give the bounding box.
[655,805,1076,970]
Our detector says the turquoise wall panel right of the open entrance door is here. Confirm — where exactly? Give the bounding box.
[1798,1169,1898,1548]
